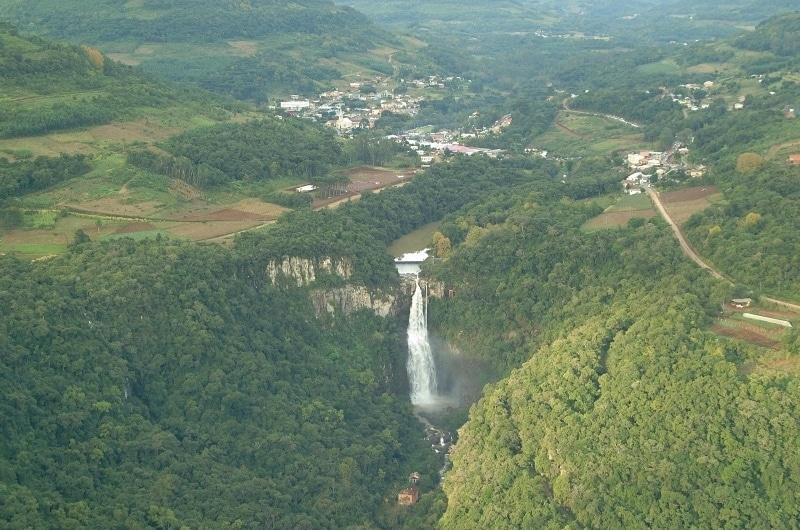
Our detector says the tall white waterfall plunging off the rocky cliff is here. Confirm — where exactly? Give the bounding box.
[406,278,436,405]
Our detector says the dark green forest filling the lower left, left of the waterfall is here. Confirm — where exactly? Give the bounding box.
[0,240,435,528]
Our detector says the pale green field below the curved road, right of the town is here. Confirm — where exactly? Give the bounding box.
[533,111,652,157]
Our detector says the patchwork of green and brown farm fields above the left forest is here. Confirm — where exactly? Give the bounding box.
[0,155,415,259]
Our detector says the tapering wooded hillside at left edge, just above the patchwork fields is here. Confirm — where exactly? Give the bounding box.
[0,25,218,138]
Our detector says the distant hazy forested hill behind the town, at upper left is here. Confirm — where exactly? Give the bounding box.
[0,0,434,101]
